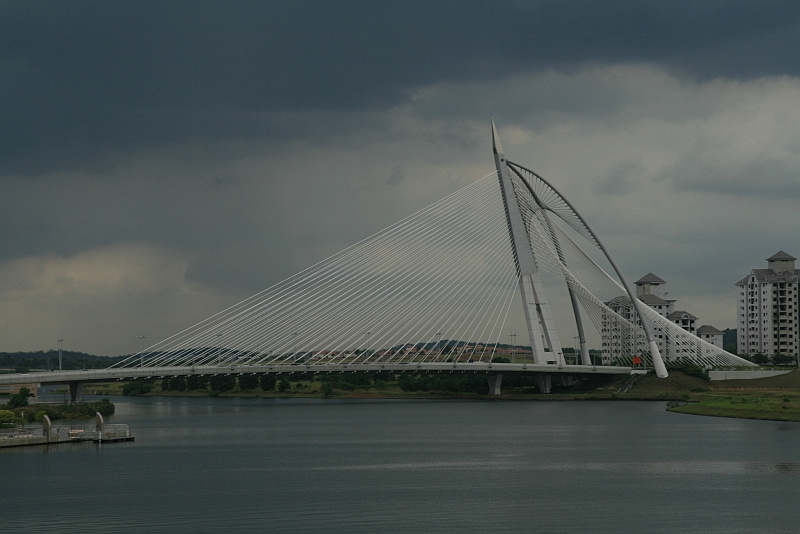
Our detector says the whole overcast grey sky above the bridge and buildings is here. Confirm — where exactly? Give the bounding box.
[0,0,800,355]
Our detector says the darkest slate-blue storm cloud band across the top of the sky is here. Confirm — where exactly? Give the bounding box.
[0,0,800,175]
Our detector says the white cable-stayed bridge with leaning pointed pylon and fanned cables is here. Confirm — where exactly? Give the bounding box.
[0,124,752,400]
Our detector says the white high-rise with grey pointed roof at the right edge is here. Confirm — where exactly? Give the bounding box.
[736,250,800,355]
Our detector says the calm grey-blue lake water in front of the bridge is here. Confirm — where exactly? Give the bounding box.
[0,398,800,533]
